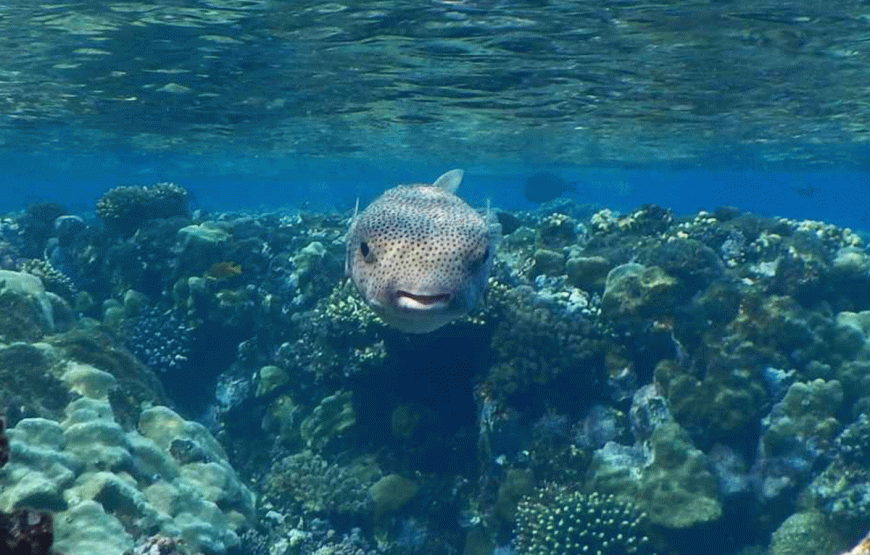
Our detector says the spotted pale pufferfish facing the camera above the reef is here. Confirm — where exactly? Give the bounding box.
[345,170,500,333]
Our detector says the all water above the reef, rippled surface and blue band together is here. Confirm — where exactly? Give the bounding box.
[0,0,870,226]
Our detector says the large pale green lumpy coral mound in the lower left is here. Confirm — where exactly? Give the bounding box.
[0,363,254,555]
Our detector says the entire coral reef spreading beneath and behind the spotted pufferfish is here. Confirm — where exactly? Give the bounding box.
[8,188,870,555]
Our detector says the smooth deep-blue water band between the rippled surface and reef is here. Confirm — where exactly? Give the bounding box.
[0,151,870,230]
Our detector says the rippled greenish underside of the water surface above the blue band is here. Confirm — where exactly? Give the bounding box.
[0,0,870,167]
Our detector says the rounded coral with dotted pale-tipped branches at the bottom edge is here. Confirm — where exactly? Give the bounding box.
[517,486,652,555]
